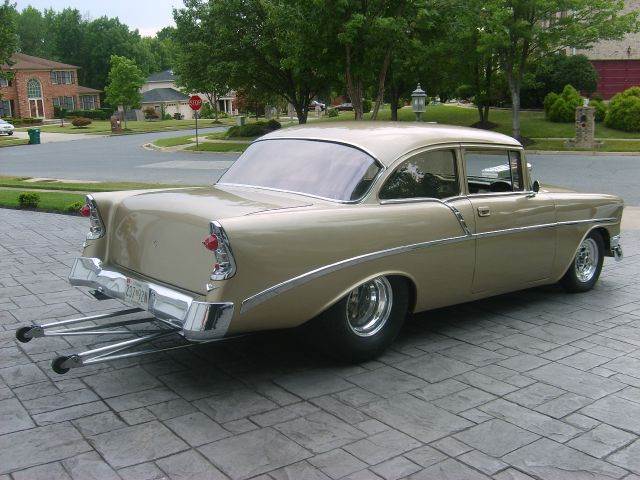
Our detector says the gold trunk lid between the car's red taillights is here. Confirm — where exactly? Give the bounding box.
[107,187,312,294]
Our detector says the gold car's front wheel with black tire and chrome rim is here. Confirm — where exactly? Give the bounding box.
[560,232,604,293]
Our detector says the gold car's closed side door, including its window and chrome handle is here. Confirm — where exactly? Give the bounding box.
[463,146,556,293]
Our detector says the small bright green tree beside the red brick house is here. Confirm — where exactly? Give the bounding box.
[105,55,145,128]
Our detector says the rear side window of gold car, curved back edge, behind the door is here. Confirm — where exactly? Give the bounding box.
[379,150,460,200]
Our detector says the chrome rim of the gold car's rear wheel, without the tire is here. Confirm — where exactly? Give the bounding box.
[346,277,393,337]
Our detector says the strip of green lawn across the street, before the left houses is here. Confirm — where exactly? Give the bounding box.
[21,118,232,134]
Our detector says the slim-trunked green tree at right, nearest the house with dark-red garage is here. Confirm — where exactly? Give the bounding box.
[482,0,639,139]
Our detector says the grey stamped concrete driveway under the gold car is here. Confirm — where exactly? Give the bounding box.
[0,210,640,480]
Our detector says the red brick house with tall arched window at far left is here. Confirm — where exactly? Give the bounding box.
[0,53,100,118]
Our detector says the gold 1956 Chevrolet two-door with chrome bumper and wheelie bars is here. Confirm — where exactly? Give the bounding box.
[17,122,623,373]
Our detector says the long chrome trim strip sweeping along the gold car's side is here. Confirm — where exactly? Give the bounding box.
[240,216,617,314]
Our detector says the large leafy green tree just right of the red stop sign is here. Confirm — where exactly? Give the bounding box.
[174,0,335,123]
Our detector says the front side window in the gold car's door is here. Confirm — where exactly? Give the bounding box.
[464,149,524,193]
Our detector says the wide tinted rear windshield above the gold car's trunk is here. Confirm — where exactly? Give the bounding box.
[218,139,381,202]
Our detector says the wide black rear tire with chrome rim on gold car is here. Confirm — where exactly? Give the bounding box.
[308,276,409,362]
